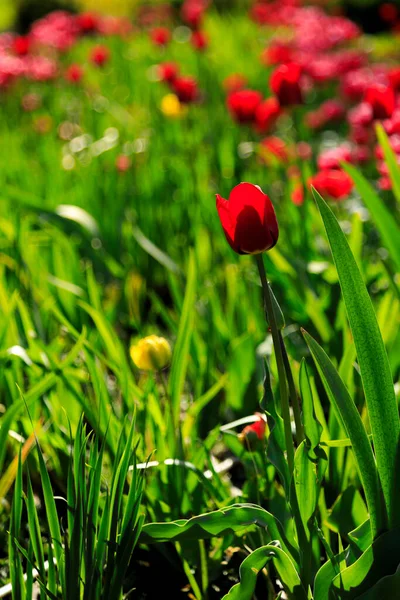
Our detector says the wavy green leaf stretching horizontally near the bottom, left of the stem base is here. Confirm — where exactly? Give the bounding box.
[140,504,298,562]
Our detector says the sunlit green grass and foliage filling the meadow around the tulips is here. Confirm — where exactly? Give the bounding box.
[0,2,400,600]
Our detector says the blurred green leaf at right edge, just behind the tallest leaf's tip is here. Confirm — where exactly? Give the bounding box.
[343,163,400,271]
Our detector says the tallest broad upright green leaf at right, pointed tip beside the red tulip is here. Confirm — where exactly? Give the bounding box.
[314,190,400,526]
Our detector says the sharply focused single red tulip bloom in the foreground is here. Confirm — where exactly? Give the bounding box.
[217,183,279,254]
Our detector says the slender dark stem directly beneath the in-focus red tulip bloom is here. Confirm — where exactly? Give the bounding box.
[256,254,294,473]
